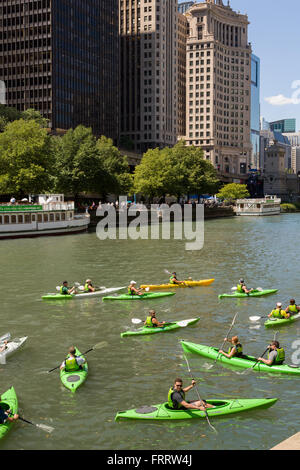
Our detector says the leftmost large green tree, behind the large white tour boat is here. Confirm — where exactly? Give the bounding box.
[0,119,53,195]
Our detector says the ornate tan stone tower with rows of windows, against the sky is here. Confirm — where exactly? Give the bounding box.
[185,0,251,181]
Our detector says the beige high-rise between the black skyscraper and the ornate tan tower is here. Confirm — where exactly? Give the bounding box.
[119,0,178,153]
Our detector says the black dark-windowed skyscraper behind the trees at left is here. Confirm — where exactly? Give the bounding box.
[0,0,119,140]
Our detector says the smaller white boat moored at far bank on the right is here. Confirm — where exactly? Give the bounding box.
[235,195,281,216]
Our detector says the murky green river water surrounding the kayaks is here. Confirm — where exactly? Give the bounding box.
[0,214,300,450]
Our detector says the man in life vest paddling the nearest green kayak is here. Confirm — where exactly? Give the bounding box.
[168,378,214,411]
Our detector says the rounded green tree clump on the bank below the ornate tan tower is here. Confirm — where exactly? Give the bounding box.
[134,141,219,198]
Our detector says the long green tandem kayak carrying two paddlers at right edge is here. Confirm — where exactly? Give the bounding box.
[181,341,300,376]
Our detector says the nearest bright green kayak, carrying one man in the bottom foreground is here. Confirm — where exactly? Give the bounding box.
[115,398,277,421]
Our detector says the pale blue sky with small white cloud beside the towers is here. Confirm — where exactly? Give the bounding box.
[180,0,300,131]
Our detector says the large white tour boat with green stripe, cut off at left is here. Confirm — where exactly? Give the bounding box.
[0,194,90,239]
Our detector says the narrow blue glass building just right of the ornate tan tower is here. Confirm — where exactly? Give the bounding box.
[250,54,260,170]
